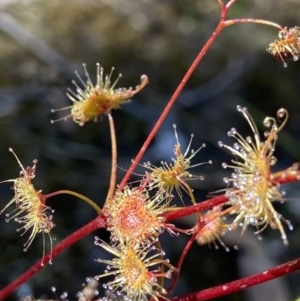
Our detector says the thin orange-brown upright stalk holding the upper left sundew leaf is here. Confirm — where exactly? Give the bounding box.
[104,113,117,205]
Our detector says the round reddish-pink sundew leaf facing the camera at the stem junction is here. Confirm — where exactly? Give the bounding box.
[105,180,170,245]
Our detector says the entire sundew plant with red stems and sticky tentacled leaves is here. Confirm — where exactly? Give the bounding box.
[0,0,300,301]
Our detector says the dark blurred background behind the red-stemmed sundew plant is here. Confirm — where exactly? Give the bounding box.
[0,0,300,301]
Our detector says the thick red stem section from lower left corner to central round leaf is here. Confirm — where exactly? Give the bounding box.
[0,216,106,300]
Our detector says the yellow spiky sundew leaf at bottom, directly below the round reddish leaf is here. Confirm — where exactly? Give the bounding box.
[95,237,175,300]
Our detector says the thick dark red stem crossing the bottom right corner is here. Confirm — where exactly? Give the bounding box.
[171,258,300,301]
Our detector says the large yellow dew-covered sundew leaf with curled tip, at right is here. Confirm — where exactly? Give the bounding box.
[219,106,293,247]
